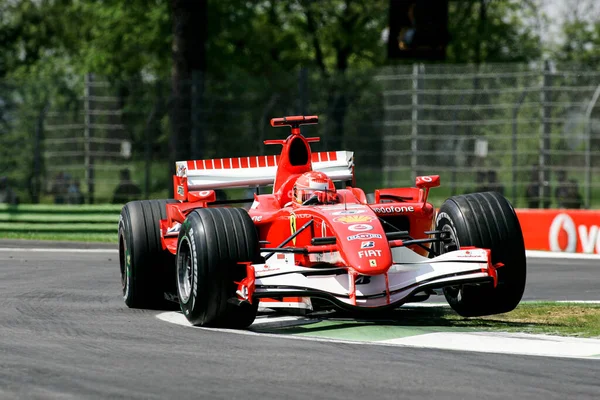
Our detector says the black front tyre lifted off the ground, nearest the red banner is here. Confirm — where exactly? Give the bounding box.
[436,192,527,317]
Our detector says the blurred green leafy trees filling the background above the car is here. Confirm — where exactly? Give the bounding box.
[0,0,600,202]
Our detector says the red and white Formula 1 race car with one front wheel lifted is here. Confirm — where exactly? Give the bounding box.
[119,116,526,328]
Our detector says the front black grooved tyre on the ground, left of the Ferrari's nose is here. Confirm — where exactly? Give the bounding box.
[176,208,260,329]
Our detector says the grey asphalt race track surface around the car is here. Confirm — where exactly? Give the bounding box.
[0,242,600,400]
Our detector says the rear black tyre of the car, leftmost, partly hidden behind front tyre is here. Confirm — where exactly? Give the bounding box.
[119,200,177,309]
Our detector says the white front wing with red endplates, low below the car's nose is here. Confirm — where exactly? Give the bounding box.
[245,248,500,309]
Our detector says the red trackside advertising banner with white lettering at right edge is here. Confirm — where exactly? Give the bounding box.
[515,209,600,254]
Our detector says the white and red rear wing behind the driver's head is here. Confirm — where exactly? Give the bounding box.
[175,151,354,193]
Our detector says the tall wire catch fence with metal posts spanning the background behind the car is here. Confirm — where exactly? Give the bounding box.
[0,62,600,208]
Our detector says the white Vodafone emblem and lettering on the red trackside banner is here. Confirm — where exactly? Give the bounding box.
[548,213,600,254]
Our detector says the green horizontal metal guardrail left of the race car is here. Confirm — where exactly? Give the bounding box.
[0,204,122,237]
